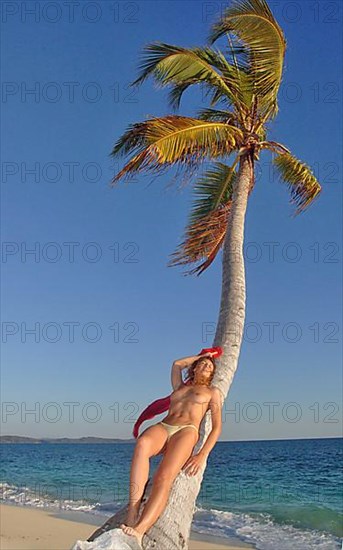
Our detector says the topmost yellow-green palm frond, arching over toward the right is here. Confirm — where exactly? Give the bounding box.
[209,0,286,118]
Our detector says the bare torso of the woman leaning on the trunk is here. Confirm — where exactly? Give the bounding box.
[163,385,211,428]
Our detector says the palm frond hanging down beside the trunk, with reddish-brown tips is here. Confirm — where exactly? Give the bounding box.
[168,162,237,275]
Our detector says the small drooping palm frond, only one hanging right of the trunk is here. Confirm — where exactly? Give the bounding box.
[273,153,321,217]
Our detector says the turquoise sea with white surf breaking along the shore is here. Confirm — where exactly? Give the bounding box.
[0,438,343,550]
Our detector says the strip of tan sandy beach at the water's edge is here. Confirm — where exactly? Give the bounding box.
[0,504,251,550]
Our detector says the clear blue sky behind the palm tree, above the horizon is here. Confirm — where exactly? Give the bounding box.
[1,1,342,440]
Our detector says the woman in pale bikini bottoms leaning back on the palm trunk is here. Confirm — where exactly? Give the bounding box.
[120,352,222,546]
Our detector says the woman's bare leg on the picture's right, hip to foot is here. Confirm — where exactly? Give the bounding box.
[120,428,198,544]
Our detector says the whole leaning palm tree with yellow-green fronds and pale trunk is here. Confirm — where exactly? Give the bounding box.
[88,0,321,550]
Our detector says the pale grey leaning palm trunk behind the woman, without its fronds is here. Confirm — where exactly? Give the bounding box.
[84,153,253,550]
